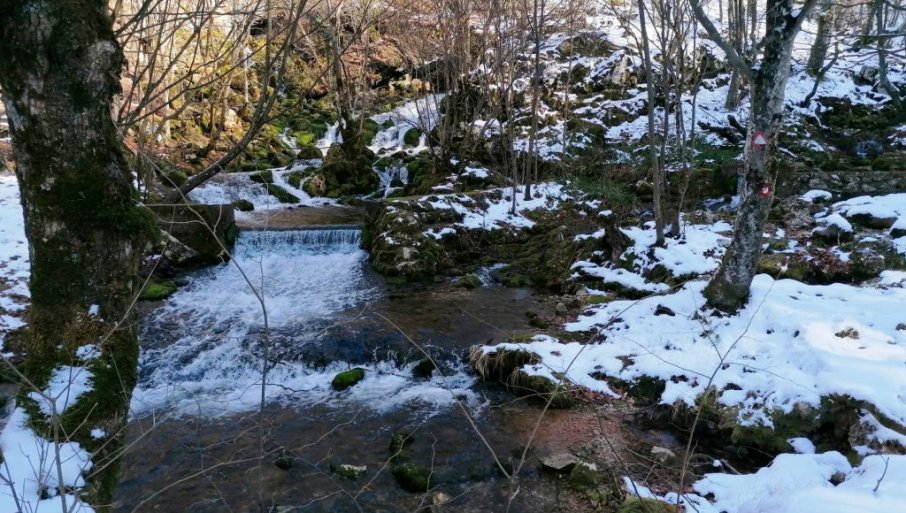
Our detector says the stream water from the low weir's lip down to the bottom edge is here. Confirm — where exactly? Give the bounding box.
[115,229,572,512]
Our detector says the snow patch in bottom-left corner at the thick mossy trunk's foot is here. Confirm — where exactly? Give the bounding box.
[0,408,94,513]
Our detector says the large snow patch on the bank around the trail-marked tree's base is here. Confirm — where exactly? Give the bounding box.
[487,275,906,426]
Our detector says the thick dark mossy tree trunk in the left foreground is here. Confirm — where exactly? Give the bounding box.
[0,0,153,504]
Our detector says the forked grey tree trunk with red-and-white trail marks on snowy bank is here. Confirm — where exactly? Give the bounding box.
[690,0,817,312]
